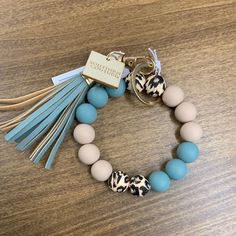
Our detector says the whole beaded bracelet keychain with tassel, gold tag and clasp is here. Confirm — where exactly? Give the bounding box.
[0,48,202,196]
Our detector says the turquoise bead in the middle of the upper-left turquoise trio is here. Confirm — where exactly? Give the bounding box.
[87,86,108,108]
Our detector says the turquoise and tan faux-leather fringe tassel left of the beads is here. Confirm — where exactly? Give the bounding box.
[0,76,89,169]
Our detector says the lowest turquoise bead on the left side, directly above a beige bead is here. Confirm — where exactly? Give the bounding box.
[75,103,97,124]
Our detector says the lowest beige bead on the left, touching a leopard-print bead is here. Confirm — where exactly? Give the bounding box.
[91,160,112,181]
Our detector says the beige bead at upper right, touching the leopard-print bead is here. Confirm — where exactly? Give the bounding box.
[162,85,184,107]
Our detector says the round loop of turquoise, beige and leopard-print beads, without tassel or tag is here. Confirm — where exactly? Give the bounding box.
[74,78,202,196]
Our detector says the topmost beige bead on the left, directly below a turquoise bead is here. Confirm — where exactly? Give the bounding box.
[74,124,95,144]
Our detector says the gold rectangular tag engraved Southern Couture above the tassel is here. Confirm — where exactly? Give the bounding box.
[82,51,125,88]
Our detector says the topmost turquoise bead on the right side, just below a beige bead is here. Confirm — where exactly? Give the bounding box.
[176,142,199,163]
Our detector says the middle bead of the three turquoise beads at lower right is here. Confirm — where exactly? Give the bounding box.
[165,159,187,180]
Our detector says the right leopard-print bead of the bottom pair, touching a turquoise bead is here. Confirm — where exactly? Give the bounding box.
[129,175,151,197]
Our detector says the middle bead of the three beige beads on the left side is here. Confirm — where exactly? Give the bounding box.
[78,143,100,165]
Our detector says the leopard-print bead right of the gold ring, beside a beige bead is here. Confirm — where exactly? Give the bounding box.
[145,75,166,97]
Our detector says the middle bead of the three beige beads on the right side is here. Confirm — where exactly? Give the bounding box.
[175,102,197,123]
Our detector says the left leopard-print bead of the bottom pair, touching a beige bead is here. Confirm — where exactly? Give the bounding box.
[108,170,129,193]
